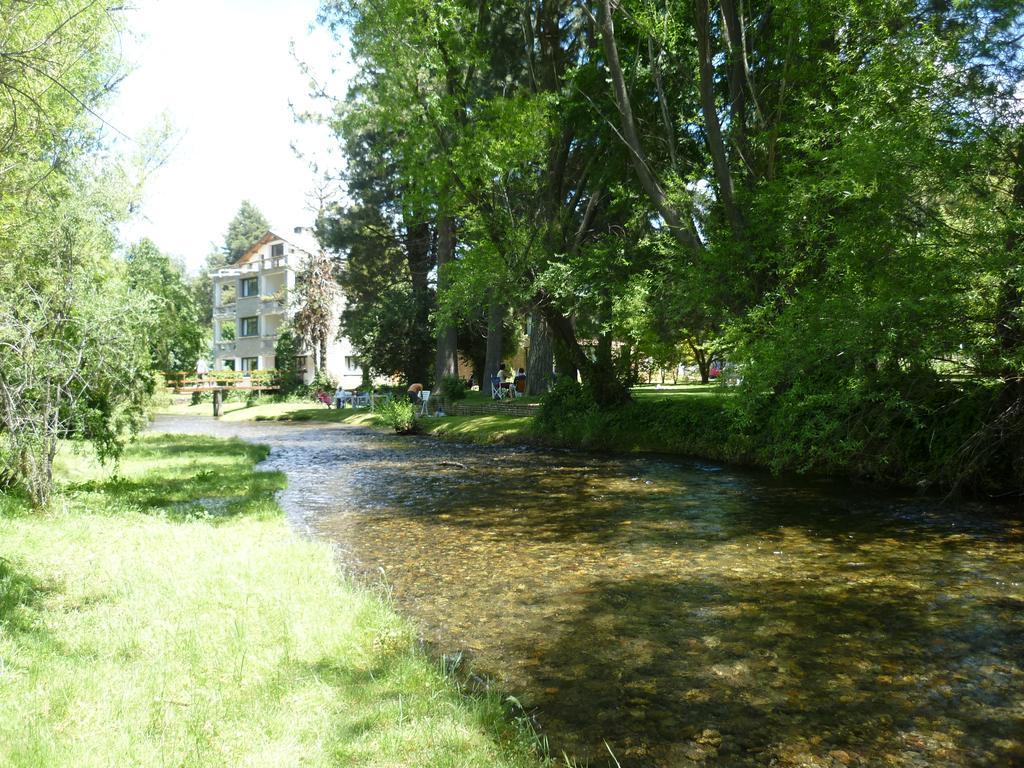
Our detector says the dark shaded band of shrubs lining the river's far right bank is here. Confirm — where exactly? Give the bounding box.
[535,380,1024,494]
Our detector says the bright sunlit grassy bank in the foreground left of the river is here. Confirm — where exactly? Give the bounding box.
[0,436,538,768]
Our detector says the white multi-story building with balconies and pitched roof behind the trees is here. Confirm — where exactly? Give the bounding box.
[211,227,362,389]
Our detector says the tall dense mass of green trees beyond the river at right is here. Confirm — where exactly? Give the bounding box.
[321,0,1024,493]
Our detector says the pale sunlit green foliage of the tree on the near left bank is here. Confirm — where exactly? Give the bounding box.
[0,2,157,506]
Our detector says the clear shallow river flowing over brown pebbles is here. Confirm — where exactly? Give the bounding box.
[156,418,1024,768]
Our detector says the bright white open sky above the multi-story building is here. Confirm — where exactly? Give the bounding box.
[103,0,351,272]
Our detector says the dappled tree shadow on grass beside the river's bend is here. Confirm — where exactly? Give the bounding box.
[66,434,286,519]
